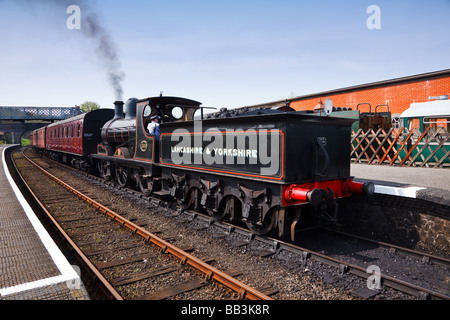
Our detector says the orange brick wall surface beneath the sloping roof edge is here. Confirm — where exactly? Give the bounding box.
[290,76,450,114]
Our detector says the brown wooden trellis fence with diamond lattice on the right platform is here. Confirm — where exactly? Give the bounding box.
[350,127,450,168]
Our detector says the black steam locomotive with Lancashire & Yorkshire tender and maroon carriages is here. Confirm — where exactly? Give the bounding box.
[31,96,374,240]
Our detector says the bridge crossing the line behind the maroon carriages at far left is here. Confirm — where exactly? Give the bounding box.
[0,106,82,144]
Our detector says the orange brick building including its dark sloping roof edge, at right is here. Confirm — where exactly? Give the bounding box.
[251,69,450,117]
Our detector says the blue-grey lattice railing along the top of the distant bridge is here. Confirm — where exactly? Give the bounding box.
[0,107,82,120]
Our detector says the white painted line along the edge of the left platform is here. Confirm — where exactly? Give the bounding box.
[0,148,81,296]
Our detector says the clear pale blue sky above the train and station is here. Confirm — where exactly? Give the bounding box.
[0,0,450,108]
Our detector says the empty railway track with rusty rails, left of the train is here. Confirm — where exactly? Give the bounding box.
[15,148,270,300]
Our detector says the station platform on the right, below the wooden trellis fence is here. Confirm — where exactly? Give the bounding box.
[350,163,450,207]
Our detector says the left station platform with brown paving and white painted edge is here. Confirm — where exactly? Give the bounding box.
[0,146,89,300]
